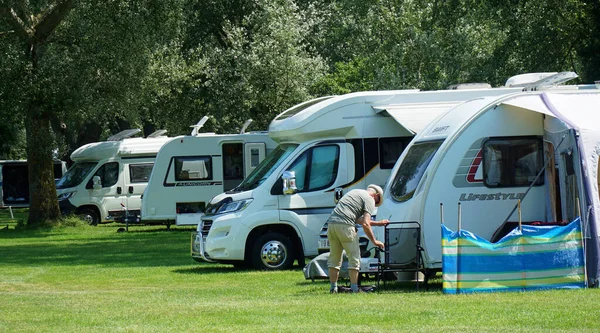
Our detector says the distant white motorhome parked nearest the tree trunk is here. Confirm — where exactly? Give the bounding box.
[56,129,171,225]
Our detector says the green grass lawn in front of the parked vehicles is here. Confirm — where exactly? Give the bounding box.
[0,212,600,332]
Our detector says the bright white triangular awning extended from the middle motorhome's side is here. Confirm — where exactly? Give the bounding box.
[373,102,461,134]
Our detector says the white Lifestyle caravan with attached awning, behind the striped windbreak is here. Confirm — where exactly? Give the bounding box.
[377,73,600,286]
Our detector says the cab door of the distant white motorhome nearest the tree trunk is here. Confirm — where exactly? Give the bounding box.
[86,161,126,221]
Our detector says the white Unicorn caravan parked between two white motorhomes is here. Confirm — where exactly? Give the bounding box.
[141,122,276,225]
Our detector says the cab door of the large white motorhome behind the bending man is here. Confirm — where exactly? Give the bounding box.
[278,143,348,256]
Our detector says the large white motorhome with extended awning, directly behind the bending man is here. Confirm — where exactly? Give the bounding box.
[192,81,532,269]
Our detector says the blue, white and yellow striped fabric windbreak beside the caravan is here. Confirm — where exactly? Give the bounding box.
[442,218,586,294]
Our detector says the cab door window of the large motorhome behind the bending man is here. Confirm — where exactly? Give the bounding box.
[288,145,340,192]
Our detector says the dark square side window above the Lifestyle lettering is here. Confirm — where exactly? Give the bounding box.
[482,137,544,187]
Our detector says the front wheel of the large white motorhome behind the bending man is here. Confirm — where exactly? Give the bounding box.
[251,232,296,271]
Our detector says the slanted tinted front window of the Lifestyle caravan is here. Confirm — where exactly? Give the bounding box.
[391,140,444,202]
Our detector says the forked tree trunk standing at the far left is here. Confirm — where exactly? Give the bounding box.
[2,0,73,227]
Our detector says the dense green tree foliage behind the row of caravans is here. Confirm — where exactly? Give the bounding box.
[0,0,600,226]
